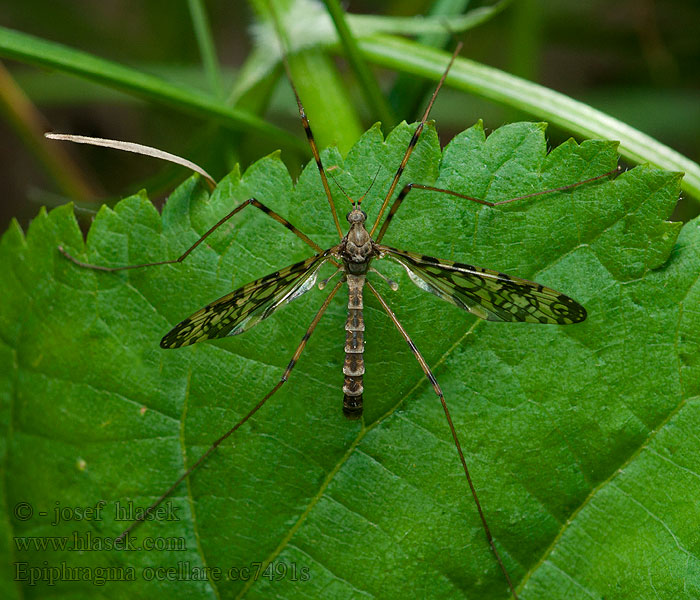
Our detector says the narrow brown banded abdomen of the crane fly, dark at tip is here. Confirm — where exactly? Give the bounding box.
[343,273,365,419]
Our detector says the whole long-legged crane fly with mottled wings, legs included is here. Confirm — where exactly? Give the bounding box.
[59,45,616,600]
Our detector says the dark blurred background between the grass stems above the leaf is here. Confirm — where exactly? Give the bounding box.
[0,0,700,230]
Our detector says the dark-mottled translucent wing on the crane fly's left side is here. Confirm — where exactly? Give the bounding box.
[160,251,330,348]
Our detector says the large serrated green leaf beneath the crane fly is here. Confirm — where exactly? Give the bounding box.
[0,118,688,599]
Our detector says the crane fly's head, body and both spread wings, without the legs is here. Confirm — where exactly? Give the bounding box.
[160,193,586,426]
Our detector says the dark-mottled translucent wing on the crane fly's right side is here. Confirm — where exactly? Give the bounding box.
[380,246,586,325]
